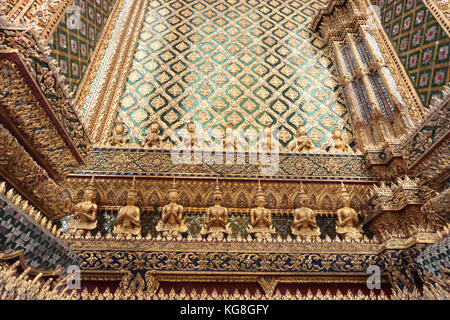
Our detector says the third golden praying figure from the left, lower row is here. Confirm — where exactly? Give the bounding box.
[156,179,187,237]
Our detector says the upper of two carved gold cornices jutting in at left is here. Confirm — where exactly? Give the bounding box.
[0,22,90,180]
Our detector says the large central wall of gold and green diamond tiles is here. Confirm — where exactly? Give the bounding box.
[117,0,351,148]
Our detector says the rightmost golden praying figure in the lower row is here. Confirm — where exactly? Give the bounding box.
[336,182,363,240]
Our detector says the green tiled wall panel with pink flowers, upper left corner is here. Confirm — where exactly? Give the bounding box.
[49,0,116,92]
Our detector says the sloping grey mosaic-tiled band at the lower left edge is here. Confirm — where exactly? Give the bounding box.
[0,194,79,270]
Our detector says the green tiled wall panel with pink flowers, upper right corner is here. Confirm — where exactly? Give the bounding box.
[373,0,450,106]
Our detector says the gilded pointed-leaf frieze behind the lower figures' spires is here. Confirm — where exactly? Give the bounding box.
[64,176,370,214]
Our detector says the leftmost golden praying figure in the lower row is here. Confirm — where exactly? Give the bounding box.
[68,176,97,236]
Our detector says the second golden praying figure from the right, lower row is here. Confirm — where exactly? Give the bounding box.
[291,183,320,239]
